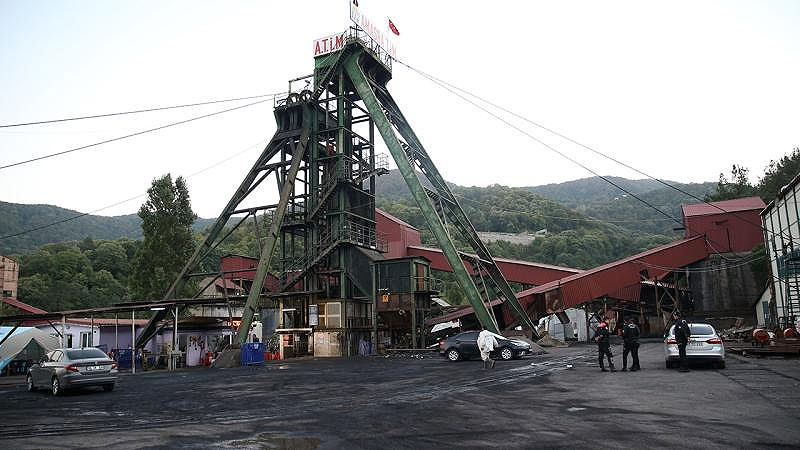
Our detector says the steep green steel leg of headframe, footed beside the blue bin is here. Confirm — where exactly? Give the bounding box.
[239,111,311,344]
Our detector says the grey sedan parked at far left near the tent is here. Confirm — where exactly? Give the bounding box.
[26,347,117,395]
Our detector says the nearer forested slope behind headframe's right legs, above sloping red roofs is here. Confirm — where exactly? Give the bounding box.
[377,171,674,268]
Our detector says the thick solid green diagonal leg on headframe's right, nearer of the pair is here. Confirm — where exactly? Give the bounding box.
[345,53,499,332]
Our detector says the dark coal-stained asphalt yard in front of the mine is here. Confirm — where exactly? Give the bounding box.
[0,343,800,449]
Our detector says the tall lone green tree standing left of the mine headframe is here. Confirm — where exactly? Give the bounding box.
[131,174,197,299]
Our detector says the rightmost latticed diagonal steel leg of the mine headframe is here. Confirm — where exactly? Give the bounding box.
[360,67,536,333]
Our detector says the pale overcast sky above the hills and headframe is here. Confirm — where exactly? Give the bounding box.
[0,0,800,217]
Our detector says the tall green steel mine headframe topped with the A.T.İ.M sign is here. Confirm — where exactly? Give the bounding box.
[136,27,534,354]
